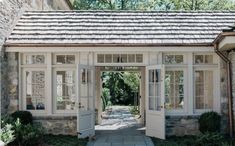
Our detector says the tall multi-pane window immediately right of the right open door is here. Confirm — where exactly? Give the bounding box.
[165,70,184,109]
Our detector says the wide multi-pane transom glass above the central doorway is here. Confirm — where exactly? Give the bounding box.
[97,54,143,63]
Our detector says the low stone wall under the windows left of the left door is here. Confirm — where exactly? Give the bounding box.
[34,116,77,135]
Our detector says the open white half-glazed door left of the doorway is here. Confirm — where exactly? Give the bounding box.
[77,65,95,138]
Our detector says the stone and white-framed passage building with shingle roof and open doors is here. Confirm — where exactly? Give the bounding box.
[2,11,235,139]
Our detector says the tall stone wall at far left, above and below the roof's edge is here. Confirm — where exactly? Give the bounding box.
[0,0,70,113]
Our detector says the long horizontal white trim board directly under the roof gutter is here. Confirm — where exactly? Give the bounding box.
[6,46,214,53]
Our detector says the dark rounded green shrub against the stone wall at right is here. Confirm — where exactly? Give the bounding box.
[198,112,221,133]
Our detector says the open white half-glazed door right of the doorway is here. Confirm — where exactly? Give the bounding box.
[146,65,165,139]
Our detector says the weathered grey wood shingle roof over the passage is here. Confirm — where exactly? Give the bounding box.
[6,11,235,45]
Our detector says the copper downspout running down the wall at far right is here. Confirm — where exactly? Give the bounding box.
[214,44,234,137]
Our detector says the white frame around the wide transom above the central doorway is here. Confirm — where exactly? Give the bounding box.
[94,51,148,66]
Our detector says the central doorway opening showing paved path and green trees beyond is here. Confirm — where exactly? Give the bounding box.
[96,66,144,131]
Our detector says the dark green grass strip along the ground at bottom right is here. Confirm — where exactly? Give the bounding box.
[152,136,234,146]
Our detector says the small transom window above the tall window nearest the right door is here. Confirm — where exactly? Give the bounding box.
[163,54,184,64]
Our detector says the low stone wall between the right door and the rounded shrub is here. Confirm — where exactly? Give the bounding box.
[166,116,199,136]
